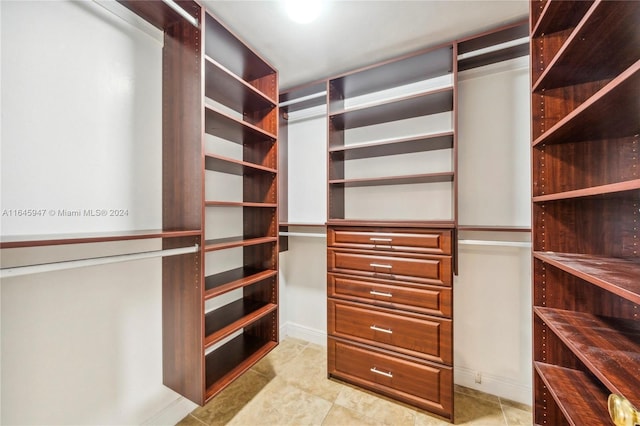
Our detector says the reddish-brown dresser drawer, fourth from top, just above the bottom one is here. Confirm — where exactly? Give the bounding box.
[327,299,453,365]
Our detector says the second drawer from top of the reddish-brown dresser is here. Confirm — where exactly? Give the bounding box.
[327,248,452,286]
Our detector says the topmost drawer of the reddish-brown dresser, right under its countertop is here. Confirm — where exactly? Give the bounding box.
[327,228,451,255]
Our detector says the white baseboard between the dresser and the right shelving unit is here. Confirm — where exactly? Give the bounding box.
[453,367,533,405]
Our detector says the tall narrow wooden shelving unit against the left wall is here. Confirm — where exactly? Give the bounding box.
[115,1,278,405]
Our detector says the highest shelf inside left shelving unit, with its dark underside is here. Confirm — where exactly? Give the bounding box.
[204,56,276,112]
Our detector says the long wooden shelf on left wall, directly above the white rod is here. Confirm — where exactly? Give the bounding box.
[0,230,201,249]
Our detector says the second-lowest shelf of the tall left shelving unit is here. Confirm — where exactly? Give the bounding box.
[204,299,278,348]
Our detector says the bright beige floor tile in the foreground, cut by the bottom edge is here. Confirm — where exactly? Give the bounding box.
[229,377,331,426]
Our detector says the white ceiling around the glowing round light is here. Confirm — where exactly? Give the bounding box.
[203,0,528,90]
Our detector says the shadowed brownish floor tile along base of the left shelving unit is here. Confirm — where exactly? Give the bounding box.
[191,370,270,426]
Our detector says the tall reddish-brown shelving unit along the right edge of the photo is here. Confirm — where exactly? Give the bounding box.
[531,0,640,424]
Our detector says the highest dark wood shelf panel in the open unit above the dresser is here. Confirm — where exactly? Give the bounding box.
[331,44,453,98]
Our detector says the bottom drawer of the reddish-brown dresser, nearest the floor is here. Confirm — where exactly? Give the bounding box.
[328,337,453,419]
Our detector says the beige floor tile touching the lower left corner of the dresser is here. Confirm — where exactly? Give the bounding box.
[278,345,343,402]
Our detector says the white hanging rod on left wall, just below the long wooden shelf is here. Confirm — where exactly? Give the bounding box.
[0,244,200,278]
